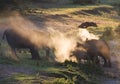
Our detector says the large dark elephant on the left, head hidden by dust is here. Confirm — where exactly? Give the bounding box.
[3,28,49,60]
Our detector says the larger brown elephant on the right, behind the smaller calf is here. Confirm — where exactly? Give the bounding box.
[84,40,111,67]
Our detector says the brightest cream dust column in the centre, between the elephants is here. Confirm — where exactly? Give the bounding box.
[48,30,76,62]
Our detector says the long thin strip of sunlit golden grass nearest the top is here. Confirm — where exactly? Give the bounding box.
[25,5,112,15]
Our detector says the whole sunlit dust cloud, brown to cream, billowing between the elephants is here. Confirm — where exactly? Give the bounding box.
[5,13,99,62]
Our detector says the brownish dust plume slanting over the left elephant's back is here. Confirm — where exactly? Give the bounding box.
[8,13,50,47]
